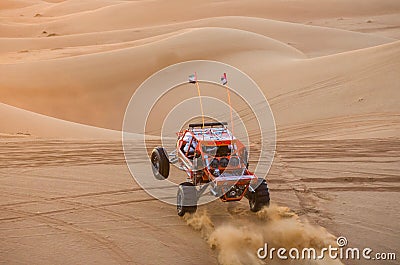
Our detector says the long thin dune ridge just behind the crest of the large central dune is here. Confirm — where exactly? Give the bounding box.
[1,16,394,56]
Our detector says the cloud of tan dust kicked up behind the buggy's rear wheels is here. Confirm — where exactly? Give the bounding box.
[184,205,342,265]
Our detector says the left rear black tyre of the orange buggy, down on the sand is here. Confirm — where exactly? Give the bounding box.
[176,182,197,216]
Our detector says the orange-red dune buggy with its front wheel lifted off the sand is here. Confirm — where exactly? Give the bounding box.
[151,122,270,216]
